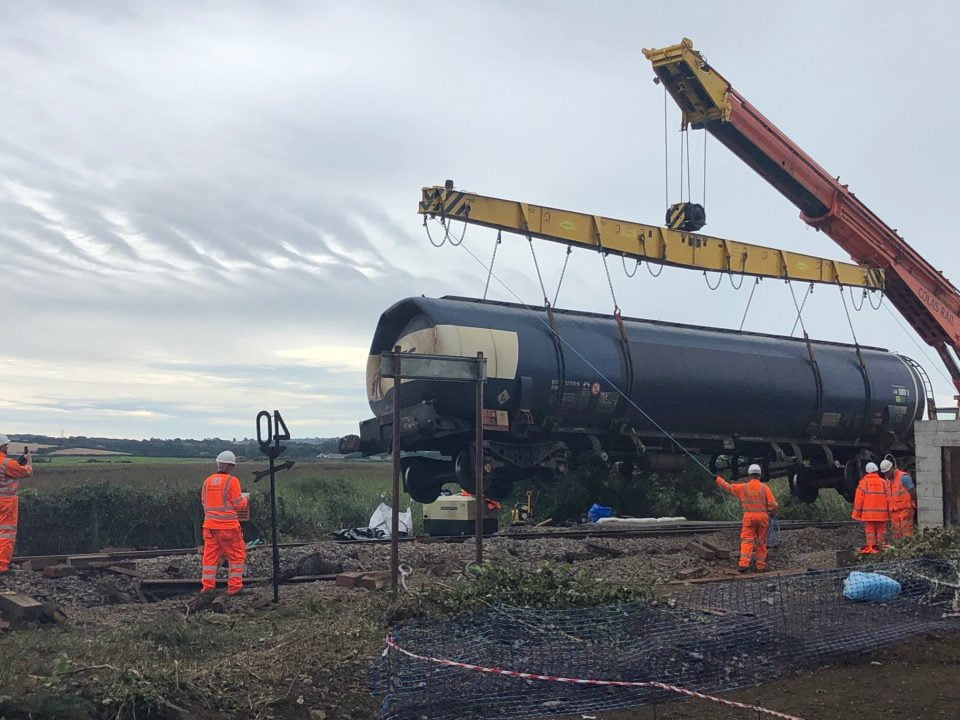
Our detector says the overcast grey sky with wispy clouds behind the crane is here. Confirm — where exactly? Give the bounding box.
[0,0,960,438]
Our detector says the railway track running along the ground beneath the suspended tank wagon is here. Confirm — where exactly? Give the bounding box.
[13,520,857,565]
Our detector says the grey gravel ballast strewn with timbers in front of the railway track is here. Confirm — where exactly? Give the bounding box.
[0,525,861,614]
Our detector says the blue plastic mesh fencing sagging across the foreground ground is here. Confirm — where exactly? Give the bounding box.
[371,559,960,720]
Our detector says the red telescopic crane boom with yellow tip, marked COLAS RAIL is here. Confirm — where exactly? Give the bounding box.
[643,39,960,399]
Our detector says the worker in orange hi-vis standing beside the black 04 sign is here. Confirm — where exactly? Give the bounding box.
[200,450,248,595]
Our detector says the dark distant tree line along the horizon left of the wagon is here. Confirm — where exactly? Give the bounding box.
[12,435,339,458]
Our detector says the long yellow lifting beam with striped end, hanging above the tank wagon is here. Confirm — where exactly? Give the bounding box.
[418,183,884,290]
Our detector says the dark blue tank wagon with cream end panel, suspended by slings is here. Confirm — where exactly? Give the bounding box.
[341,297,925,502]
